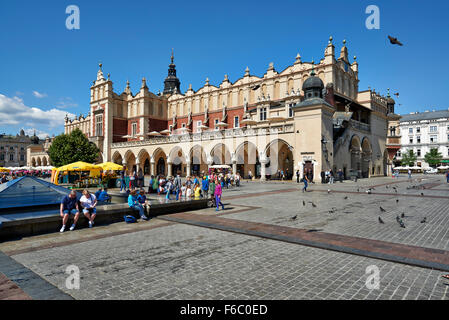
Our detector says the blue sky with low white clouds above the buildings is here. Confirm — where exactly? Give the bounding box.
[0,0,449,136]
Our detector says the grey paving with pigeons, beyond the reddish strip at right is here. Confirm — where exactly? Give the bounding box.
[224,177,449,250]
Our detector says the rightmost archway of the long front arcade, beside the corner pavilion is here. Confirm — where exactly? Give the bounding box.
[265,139,293,179]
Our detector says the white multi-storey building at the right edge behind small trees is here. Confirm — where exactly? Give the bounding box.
[396,110,449,167]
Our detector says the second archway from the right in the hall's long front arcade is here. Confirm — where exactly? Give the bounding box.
[235,141,260,177]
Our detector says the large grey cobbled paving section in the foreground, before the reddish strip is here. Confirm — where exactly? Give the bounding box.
[7,224,449,300]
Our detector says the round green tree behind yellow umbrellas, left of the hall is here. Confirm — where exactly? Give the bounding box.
[48,129,100,167]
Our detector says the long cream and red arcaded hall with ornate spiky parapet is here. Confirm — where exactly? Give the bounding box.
[65,37,394,180]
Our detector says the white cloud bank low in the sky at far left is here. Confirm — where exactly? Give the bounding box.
[0,94,75,128]
